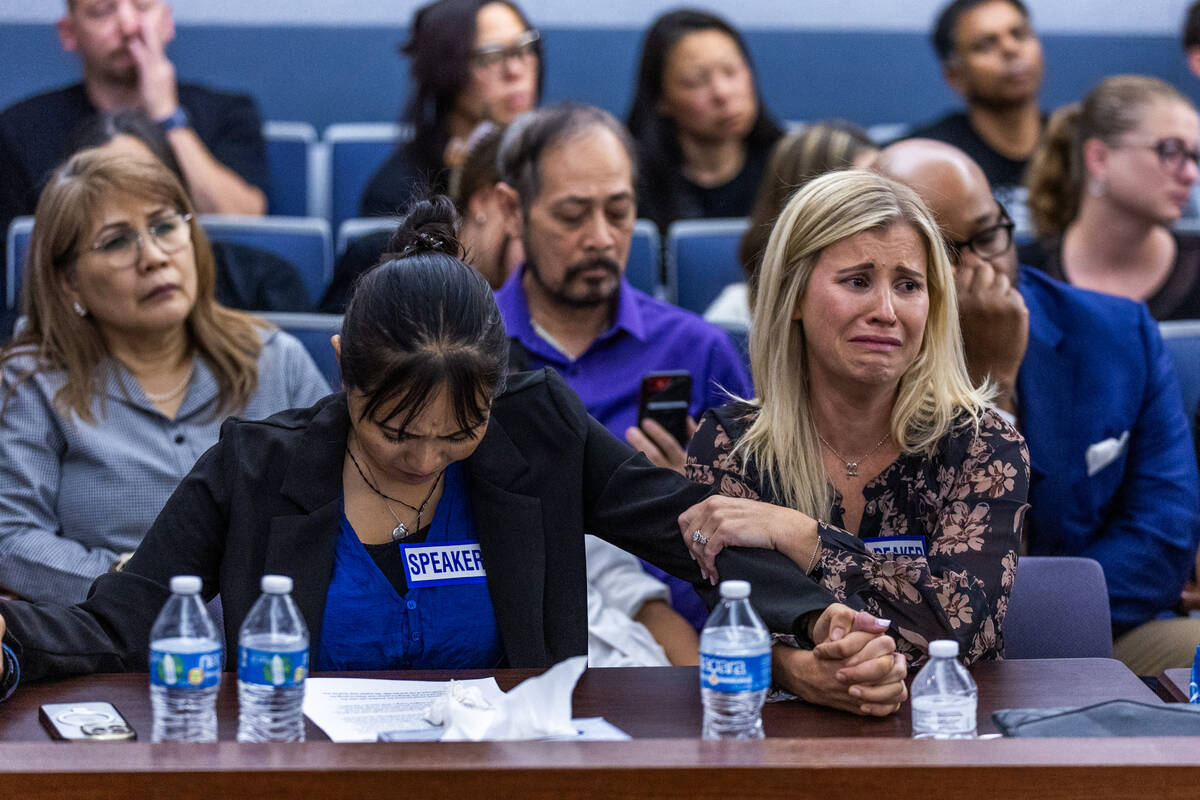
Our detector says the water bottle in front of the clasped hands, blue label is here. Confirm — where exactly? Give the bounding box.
[700,581,770,739]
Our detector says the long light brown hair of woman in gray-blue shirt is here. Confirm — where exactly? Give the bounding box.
[0,148,266,422]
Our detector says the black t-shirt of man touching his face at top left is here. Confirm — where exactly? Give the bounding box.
[0,83,266,252]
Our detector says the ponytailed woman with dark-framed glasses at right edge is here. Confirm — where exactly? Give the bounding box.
[1021,76,1200,320]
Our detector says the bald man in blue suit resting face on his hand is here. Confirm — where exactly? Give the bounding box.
[875,139,1200,675]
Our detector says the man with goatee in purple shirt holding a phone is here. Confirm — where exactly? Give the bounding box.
[496,106,752,628]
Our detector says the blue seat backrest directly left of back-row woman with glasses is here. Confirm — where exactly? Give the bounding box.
[325,122,412,230]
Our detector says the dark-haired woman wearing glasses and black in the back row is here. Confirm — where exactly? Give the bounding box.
[361,0,544,217]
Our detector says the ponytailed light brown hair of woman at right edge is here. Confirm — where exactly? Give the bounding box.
[1025,76,1195,236]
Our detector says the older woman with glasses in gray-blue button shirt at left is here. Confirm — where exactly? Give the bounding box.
[0,149,329,603]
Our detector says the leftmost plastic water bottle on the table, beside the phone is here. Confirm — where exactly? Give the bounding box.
[150,575,221,741]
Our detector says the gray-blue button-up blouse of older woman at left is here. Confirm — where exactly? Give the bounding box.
[0,330,329,603]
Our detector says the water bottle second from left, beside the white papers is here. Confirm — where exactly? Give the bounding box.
[238,575,308,741]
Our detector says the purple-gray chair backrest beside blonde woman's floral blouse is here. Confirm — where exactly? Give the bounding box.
[1004,555,1112,658]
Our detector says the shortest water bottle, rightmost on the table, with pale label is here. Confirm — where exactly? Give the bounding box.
[912,639,978,739]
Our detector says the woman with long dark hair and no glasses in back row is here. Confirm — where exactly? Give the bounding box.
[626,8,784,231]
